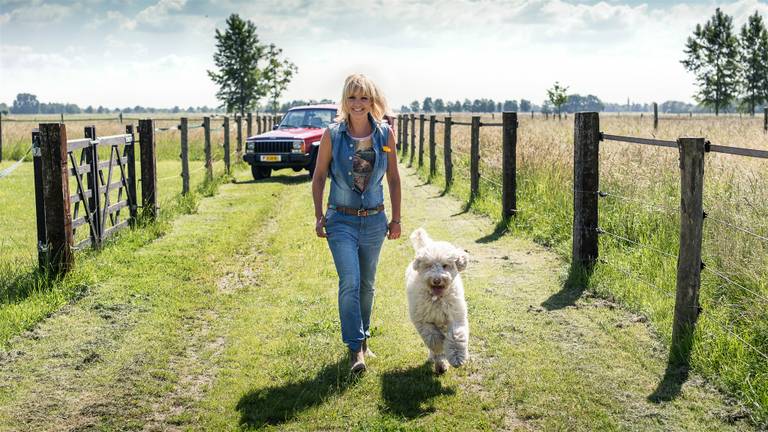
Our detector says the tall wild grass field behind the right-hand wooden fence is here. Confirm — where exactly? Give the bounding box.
[404,111,768,424]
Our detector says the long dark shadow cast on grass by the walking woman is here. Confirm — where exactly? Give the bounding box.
[236,358,358,428]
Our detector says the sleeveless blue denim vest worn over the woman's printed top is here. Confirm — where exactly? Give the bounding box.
[328,114,389,209]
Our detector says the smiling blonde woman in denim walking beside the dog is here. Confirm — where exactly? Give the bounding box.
[312,74,400,373]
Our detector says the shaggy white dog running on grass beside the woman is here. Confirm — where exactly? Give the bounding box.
[405,228,469,374]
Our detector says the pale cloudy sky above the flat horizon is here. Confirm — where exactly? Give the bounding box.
[0,0,768,108]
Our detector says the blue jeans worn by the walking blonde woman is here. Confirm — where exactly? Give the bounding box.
[325,209,387,351]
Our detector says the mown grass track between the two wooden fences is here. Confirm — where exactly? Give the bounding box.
[0,164,748,431]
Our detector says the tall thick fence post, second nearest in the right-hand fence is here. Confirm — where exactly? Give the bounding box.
[571,112,600,269]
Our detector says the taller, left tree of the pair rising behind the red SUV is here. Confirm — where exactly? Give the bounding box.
[208,14,265,117]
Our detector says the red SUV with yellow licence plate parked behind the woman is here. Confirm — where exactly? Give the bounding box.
[243,104,337,180]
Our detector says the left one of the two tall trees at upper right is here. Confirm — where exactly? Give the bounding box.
[680,8,739,115]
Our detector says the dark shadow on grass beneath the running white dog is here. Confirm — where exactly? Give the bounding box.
[381,362,456,419]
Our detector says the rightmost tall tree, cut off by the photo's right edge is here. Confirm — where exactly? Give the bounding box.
[739,11,768,115]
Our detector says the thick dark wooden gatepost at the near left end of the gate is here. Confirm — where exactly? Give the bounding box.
[40,123,73,276]
